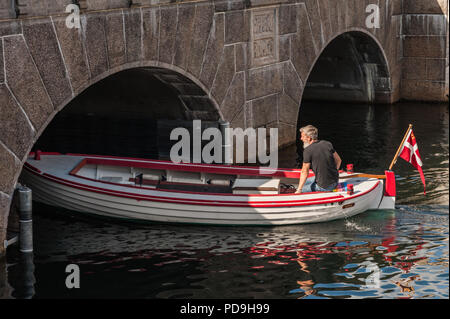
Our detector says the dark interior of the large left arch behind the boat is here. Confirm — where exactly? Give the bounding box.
[33,68,220,159]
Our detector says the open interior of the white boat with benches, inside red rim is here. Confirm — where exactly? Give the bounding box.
[70,159,306,194]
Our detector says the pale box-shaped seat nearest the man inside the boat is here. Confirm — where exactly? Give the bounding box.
[233,178,280,194]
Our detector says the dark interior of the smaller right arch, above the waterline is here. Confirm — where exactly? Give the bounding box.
[303,32,391,103]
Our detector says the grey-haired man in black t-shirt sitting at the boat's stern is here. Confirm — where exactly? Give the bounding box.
[295,125,342,194]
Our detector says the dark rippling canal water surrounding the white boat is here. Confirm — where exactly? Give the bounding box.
[0,103,449,299]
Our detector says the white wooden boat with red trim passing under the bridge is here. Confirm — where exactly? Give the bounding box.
[20,151,395,225]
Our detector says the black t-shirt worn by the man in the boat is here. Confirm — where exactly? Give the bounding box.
[303,140,339,188]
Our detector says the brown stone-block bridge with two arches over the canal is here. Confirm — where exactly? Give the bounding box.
[0,0,448,254]
